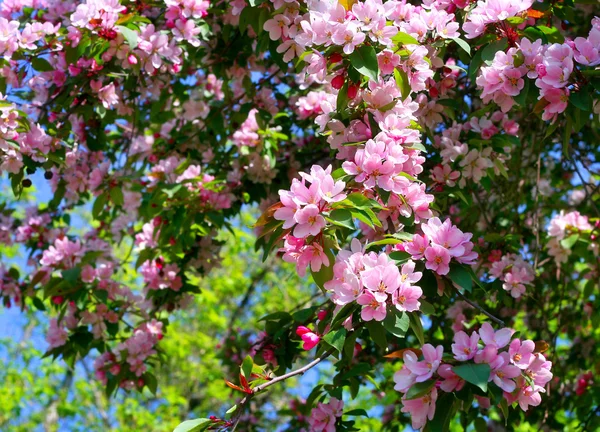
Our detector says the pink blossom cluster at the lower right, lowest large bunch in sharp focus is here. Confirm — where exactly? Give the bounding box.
[394,323,552,429]
